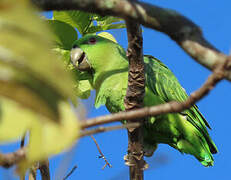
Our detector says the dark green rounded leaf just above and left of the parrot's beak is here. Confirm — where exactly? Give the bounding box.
[48,20,78,49]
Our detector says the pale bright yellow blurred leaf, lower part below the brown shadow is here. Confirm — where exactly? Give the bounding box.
[0,98,80,172]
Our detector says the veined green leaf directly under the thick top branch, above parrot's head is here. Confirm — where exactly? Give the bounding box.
[53,11,92,35]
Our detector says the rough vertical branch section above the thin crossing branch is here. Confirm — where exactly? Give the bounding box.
[124,21,145,111]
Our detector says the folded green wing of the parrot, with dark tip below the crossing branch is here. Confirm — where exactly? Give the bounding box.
[144,56,217,164]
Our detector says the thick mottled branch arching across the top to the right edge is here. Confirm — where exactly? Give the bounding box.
[32,0,231,81]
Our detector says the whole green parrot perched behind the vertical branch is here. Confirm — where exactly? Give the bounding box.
[71,34,217,166]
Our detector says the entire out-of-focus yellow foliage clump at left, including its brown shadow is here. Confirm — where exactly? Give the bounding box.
[0,0,79,172]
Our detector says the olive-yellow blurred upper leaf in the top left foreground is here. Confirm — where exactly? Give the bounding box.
[0,0,73,121]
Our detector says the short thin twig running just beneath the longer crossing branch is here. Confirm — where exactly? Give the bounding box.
[79,123,140,137]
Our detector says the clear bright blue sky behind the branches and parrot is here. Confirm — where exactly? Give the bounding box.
[0,0,231,180]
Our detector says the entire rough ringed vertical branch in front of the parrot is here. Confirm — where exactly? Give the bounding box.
[124,19,145,180]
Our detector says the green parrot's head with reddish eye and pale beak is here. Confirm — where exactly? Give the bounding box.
[71,33,126,77]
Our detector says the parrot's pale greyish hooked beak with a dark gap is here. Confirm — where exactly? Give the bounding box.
[71,47,91,71]
